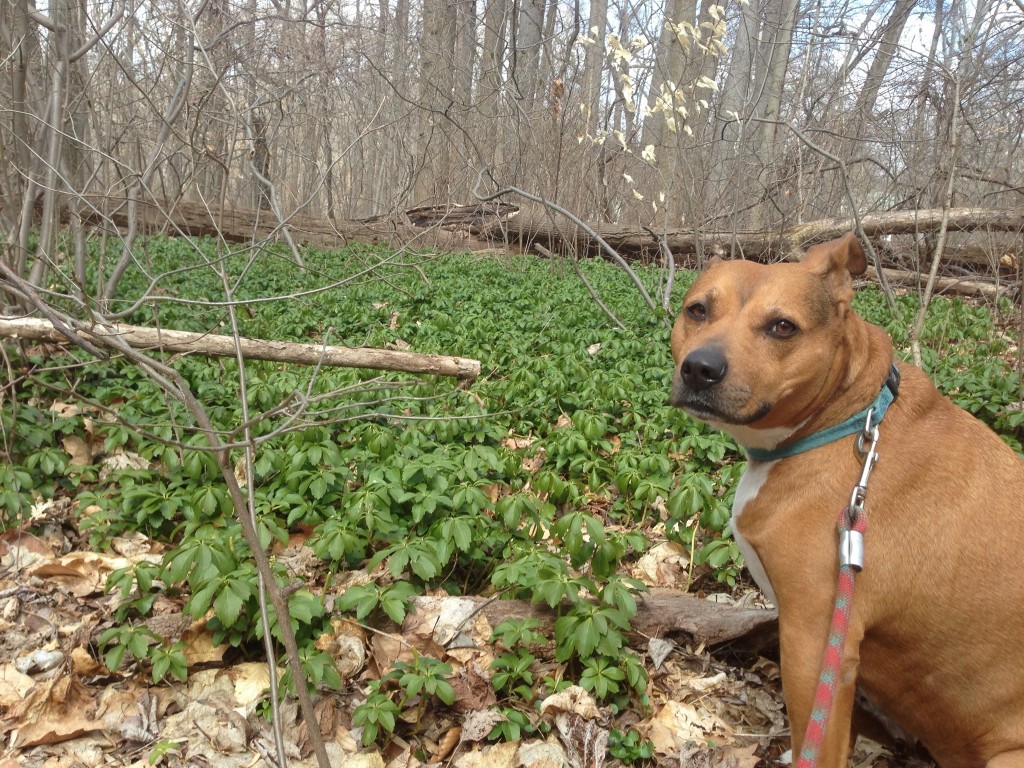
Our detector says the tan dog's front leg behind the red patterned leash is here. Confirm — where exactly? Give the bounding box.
[779,617,863,768]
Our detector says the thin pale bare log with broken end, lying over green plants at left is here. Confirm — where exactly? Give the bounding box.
[0,317,480,380]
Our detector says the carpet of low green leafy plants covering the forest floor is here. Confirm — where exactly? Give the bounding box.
[0,239,1024,745]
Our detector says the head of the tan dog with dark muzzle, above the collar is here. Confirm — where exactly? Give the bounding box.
[671,233,867,447]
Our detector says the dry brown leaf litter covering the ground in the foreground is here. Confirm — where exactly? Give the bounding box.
[0,500,929,768]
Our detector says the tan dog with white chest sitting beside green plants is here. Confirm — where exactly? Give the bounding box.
[672,234,1024,768]
